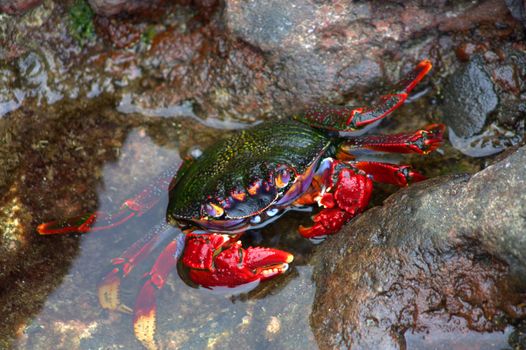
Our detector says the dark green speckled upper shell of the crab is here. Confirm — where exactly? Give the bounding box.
[167,120,331,220]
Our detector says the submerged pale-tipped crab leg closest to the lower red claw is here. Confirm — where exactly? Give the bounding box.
[133,233,185,349]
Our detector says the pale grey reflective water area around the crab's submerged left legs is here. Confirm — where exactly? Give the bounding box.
[10,127,316,349]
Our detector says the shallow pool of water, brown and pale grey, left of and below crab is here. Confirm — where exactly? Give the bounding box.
[1,96,326,349]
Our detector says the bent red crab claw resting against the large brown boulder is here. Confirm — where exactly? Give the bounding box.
[298,160,373,239]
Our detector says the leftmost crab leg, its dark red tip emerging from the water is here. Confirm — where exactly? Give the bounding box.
[37,166,179,235]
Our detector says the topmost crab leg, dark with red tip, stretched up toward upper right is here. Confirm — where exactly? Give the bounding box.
[296,60,432,131]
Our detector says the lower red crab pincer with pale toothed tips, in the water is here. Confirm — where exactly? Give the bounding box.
[183,234,294,289]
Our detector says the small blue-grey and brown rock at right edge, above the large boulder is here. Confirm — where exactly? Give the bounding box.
[441,49,526,157]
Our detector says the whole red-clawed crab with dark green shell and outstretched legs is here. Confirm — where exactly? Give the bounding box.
[38,60,444,348]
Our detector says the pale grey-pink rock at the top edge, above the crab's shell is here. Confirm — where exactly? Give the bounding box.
[224,0,506,113]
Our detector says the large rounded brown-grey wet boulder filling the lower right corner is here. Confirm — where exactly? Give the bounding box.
[311,147,526,349]
